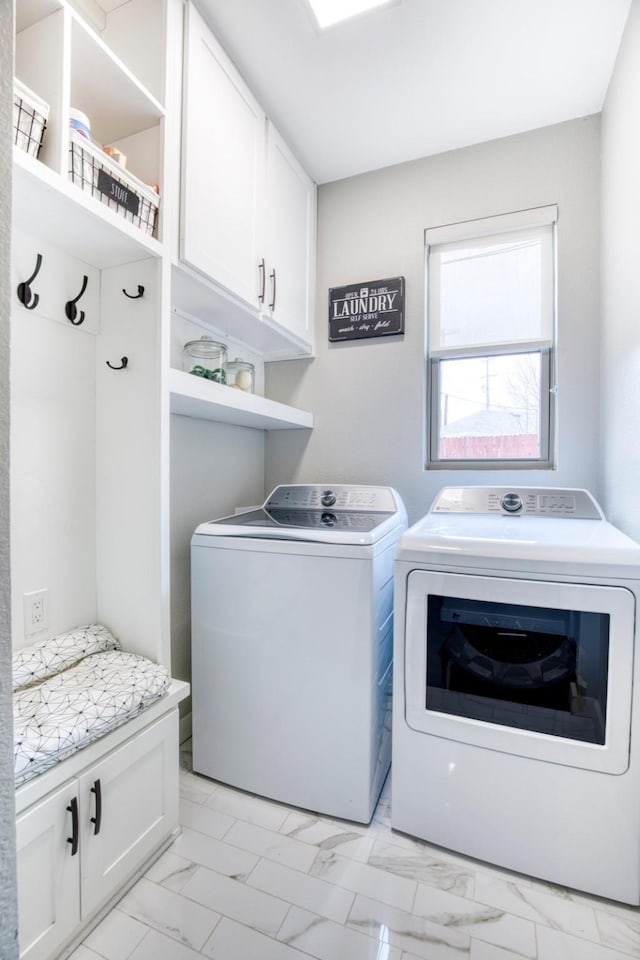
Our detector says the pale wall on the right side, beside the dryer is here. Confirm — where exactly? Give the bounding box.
[601,0,640,540]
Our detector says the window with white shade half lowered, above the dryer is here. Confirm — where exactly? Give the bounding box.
[425,206,557,469]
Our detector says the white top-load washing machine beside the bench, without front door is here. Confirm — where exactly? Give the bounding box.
[191,484,407,823]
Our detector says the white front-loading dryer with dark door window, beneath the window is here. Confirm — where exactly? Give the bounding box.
[391,487,640,904]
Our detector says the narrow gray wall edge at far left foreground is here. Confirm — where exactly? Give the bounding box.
[0,3,18,960]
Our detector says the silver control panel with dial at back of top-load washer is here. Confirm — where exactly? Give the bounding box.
[264,483,397,513]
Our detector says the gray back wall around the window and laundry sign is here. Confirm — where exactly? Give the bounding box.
[266,117,600,522]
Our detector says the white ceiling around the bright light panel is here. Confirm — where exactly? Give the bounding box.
[196,0,631,183]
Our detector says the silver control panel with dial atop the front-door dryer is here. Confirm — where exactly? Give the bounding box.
[431,487,604,520]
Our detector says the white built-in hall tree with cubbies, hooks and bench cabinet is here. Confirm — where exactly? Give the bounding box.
[11,0,188,960]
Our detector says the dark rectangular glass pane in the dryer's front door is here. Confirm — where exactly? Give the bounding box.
[425,595,610,744]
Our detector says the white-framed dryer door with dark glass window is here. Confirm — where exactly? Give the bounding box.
[405,570,635,774]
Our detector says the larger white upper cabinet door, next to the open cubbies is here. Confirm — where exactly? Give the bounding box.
[180,4,266,310]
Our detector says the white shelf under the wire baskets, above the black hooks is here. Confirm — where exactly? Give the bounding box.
[13,147,162,269]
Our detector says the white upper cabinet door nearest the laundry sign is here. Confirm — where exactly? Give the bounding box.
[266,124,316,346]
